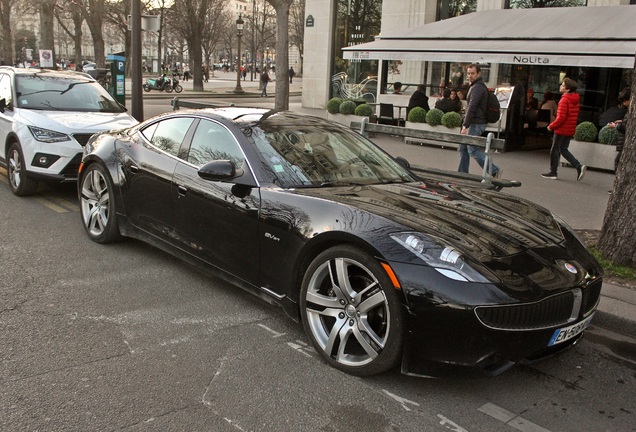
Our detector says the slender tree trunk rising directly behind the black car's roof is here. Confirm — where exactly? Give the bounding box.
[267,0,294,110]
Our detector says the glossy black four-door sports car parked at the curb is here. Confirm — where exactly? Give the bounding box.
[78,108,602,375]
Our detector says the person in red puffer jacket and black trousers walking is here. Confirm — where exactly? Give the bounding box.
[541,78,587,180]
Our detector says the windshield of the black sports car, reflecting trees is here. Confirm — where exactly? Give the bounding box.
[243,113,415,188]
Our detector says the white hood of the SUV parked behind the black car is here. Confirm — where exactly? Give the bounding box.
[20,109,137,133]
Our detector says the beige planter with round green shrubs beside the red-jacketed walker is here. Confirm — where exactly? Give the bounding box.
[561,121,616,171]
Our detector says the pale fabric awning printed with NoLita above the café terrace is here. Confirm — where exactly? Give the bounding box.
[343,6,636,69]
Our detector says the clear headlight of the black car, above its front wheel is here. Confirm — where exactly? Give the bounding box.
[391,232,498,283]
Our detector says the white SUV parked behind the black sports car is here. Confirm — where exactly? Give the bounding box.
[0,66,137,196]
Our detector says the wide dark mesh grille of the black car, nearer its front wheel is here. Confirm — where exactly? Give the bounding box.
[475,290,580,330]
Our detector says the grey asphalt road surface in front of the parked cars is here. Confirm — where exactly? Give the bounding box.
[0,98,636,432]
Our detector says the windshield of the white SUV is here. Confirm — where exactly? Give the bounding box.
[16,73,124,113]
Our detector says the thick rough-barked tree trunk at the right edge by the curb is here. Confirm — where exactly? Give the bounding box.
[597,57,636,267]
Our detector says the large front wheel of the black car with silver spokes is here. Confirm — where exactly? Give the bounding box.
[300,246,404,376]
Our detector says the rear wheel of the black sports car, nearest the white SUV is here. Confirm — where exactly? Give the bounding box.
[79,163,122,243]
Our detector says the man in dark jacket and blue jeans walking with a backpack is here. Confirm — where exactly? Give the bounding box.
[457,64,501,177]
